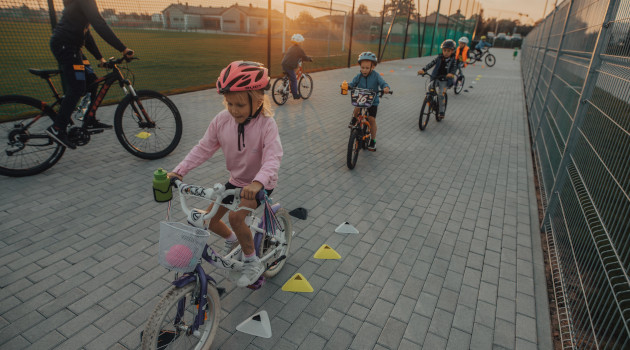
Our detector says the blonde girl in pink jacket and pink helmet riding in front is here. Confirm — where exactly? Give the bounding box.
[168,61,283,287]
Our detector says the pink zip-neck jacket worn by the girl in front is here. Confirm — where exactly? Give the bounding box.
[173,109,282,190]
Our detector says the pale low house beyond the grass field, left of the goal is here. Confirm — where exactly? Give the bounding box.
[162,4,282,34]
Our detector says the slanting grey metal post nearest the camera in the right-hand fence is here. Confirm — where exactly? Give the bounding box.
[541,0,621,230]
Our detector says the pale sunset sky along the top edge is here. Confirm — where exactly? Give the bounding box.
[7,0,556,23]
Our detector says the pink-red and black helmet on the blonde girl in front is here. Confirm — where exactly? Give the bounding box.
[217,61,271,94]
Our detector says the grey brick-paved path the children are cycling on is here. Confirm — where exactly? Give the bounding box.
[0,50,551,350]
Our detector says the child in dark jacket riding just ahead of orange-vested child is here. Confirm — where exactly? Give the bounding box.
[418,39,457,118]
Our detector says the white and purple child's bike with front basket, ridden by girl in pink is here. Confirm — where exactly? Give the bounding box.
[141,179,293,350]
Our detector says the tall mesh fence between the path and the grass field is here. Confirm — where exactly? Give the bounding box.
[0,0,480,101]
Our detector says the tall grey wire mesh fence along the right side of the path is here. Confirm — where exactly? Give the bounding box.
[521,0,630,349]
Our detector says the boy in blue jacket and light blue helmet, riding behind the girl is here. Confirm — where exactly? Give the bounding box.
[348,51,389,152]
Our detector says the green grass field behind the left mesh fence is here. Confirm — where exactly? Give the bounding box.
[0,21,424,101]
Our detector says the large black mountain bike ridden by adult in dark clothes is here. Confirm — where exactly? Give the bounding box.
[0,57,182,177]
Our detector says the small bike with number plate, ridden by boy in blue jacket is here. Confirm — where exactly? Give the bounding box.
[346,88,394,170]
